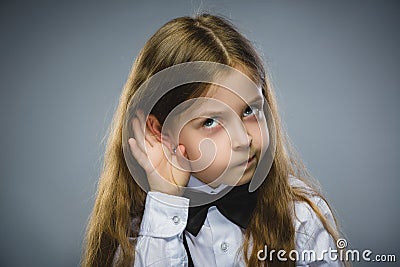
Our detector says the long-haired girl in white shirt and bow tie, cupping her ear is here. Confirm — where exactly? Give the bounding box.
[82,14,343,266]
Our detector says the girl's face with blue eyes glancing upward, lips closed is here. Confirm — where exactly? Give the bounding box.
[166,80,269,187]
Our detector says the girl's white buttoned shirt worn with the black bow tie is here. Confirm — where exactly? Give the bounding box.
[123,176,342,267]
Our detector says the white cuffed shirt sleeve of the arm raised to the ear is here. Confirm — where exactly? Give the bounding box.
[134,192,189,267]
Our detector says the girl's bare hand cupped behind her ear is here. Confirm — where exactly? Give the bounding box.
[128,111,190,196]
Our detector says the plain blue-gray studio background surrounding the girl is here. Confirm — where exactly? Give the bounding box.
[0,1,400,266]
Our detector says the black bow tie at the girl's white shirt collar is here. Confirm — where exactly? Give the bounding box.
[186,183,257,236]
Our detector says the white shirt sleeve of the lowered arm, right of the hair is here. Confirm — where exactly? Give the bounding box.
[295,197,343,267]
